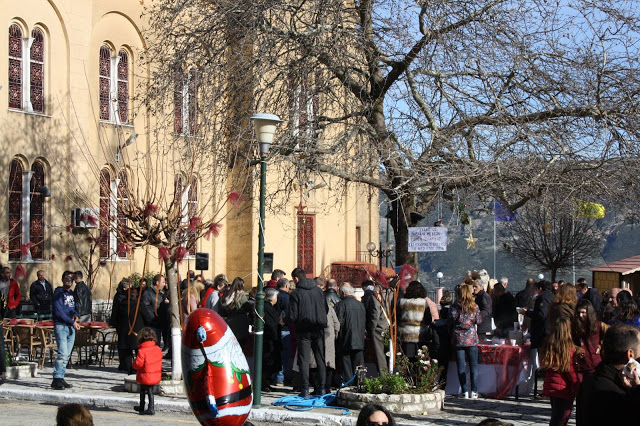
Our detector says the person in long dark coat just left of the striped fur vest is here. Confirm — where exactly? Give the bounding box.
[362,280,389,374]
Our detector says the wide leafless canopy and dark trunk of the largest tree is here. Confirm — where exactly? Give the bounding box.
[147,0,640,263]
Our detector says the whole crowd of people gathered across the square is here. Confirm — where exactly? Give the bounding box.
[6,267,640,425]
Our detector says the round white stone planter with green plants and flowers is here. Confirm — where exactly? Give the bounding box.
[338,346,444,415]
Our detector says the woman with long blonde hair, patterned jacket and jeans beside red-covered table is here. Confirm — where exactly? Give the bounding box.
[449,284,482,399]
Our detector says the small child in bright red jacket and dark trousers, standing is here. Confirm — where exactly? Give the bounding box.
[133,327,162,415]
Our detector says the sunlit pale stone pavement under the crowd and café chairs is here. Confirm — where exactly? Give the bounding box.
[0,352,575,426]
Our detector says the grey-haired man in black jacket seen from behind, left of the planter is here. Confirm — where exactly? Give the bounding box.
[336,283,367,383]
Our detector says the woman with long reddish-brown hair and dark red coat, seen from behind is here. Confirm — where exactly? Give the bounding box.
[540,317,584,426]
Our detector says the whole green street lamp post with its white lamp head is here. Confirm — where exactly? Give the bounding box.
[251,113,281,406]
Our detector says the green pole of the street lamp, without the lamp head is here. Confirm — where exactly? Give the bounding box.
[253,153,267,407]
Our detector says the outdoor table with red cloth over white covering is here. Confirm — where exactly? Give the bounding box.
[445,343,533,399]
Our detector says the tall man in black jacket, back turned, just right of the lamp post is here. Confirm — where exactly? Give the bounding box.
[287,268,329,398]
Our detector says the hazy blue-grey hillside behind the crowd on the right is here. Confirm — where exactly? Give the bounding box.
[380,203,640,291]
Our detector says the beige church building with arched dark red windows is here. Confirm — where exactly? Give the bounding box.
[0,0,379,300]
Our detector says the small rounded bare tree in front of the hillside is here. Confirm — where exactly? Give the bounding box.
[504,203,604,281]
